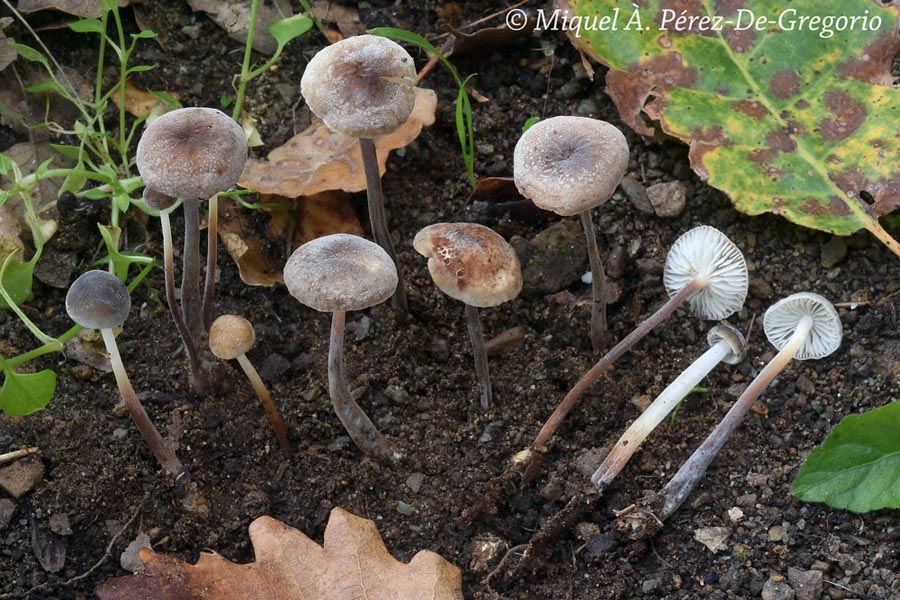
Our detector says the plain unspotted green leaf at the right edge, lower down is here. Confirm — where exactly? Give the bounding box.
[791,402,900,512]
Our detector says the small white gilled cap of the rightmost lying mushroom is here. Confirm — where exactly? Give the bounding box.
[763,292,843,360]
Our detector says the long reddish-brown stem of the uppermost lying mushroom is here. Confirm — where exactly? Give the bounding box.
[531,277,707,450]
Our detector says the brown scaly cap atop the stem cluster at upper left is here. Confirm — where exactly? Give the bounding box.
[137,108,247,200]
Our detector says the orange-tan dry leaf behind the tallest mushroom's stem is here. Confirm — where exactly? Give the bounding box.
[238,88,437,198]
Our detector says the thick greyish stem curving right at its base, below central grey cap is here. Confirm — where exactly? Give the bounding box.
[328,310,401,461]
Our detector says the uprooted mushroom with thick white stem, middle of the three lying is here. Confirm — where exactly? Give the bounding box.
[591,324,747,493]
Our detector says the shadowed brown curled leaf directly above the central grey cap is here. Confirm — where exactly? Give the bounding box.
[219,191,363,286]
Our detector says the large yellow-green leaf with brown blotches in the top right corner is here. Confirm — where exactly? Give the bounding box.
[562,0,900,255]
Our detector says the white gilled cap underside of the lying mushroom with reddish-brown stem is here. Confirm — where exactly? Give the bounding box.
[663,225,750,321]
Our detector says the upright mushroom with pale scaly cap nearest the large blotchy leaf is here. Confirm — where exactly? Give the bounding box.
[513,117,628,353]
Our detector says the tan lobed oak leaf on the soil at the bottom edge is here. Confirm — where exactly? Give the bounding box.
[97,508,463,600]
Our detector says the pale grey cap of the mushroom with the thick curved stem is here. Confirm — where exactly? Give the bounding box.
[284,233,397,312]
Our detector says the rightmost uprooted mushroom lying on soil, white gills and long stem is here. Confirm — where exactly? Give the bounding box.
[628,292,842,537]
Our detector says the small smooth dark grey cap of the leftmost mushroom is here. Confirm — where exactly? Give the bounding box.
[66,270,131,329]
